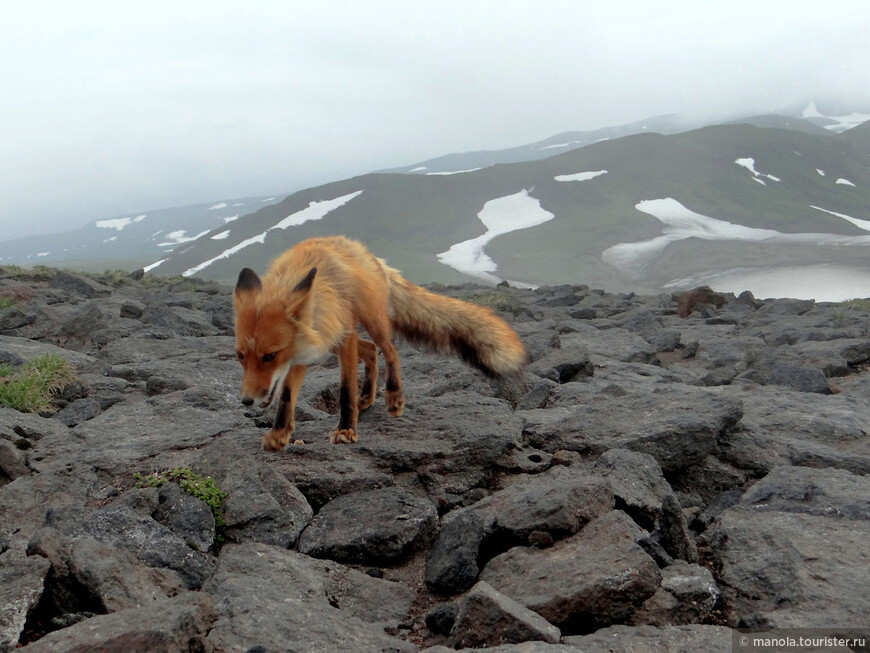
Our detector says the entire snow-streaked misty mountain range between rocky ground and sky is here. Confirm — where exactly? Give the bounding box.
[0,104,870,299]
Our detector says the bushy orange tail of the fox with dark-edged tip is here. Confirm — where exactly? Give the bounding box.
[386,268,526,377]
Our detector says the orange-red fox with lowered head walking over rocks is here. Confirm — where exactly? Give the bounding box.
[234,236,526,451]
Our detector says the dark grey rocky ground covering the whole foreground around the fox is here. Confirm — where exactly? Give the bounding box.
[0,271,870,652]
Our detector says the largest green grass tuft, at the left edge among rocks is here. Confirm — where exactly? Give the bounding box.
[0,354,75,413]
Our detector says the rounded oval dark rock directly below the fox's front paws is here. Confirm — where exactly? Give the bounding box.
[299,488,438,564]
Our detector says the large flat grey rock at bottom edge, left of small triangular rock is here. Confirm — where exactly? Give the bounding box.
[204,543,417,652]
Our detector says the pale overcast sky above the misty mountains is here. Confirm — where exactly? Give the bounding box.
[0,0,870,240]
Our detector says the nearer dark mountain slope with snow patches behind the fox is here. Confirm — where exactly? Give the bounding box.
[155,124,870,295]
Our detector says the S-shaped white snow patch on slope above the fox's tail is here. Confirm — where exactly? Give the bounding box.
[438,190,556,283]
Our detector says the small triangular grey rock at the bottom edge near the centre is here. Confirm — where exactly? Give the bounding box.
[450,582,561,648]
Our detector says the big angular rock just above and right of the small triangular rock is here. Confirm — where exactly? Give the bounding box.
[481,511,661,634]
